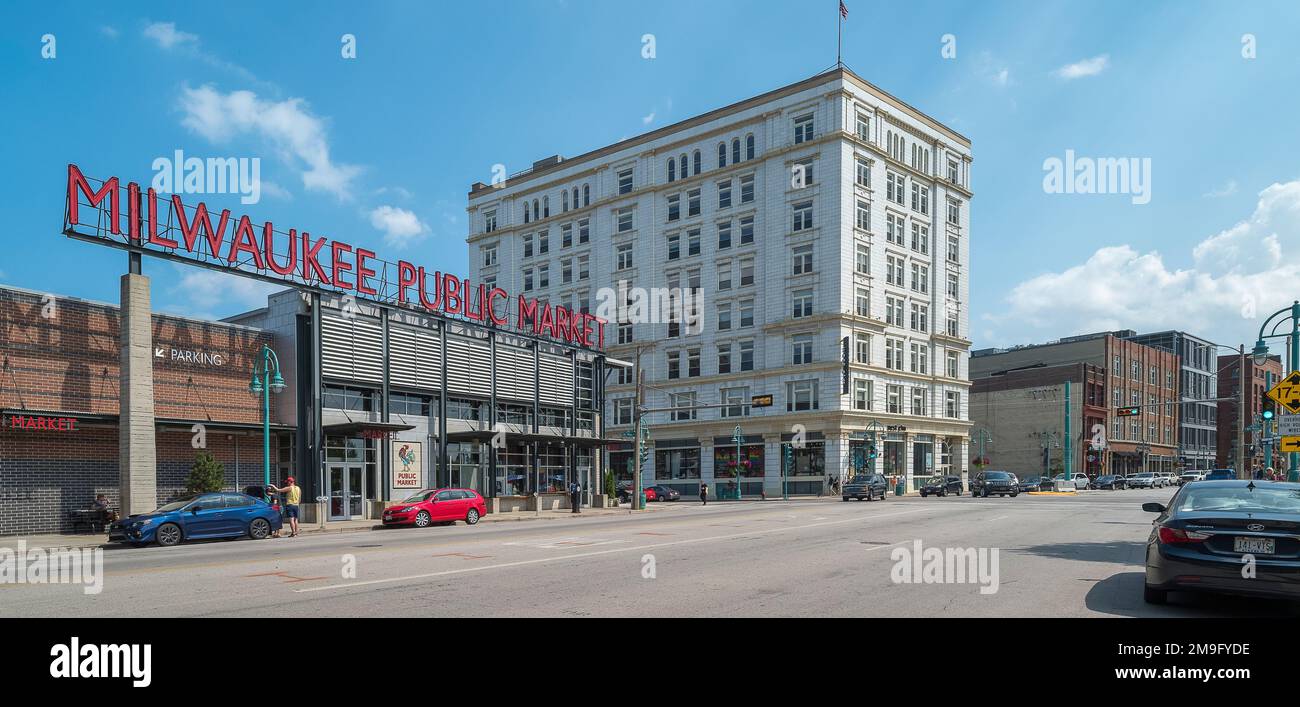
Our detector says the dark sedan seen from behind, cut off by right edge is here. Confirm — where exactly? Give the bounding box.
[1143,480,1300,604]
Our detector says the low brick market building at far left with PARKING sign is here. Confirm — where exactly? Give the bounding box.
[0,289,274,535]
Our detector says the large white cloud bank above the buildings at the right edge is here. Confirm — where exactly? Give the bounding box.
[985,181,1300,346]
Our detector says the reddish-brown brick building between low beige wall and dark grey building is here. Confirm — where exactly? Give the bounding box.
[971,330,1179,476]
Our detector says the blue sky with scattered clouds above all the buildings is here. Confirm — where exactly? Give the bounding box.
[0,0,1300,347]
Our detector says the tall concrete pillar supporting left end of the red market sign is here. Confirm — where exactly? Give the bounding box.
[117,274,157,517]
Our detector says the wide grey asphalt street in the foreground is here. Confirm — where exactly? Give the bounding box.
[0,489,1290,617]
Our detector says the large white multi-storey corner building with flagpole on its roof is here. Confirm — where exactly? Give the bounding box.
[468,69,972,495]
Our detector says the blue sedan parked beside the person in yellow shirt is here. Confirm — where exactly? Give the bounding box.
[108,493,282,547]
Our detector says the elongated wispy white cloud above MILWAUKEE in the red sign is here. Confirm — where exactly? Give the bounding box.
[179,86,361,200]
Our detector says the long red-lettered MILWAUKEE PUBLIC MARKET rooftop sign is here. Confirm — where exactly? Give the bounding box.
[64,164,606,350]
